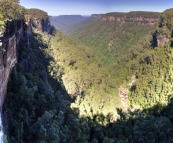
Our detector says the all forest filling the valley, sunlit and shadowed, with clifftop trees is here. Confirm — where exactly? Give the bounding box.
[0,0,173,143]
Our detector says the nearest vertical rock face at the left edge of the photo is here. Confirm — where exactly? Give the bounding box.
[0,21,24,108]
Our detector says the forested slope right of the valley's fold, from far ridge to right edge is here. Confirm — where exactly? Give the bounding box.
[69,9,172,114]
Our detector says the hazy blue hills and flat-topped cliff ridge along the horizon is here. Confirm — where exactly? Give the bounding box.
[50,11,160,35]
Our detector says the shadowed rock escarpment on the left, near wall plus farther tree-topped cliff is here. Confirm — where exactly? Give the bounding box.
[0,9,53,107]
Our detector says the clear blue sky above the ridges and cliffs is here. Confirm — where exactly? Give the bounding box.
[20,0,173,16]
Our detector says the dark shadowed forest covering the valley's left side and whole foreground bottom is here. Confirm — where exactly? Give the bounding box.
[3,30,173,143]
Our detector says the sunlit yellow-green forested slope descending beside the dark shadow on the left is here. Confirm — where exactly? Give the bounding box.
[38,28,121,116]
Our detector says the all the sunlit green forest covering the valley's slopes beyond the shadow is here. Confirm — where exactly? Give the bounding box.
[43,9,171,120]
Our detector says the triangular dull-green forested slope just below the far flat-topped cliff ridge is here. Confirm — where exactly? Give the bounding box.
[72,20,152,65]
